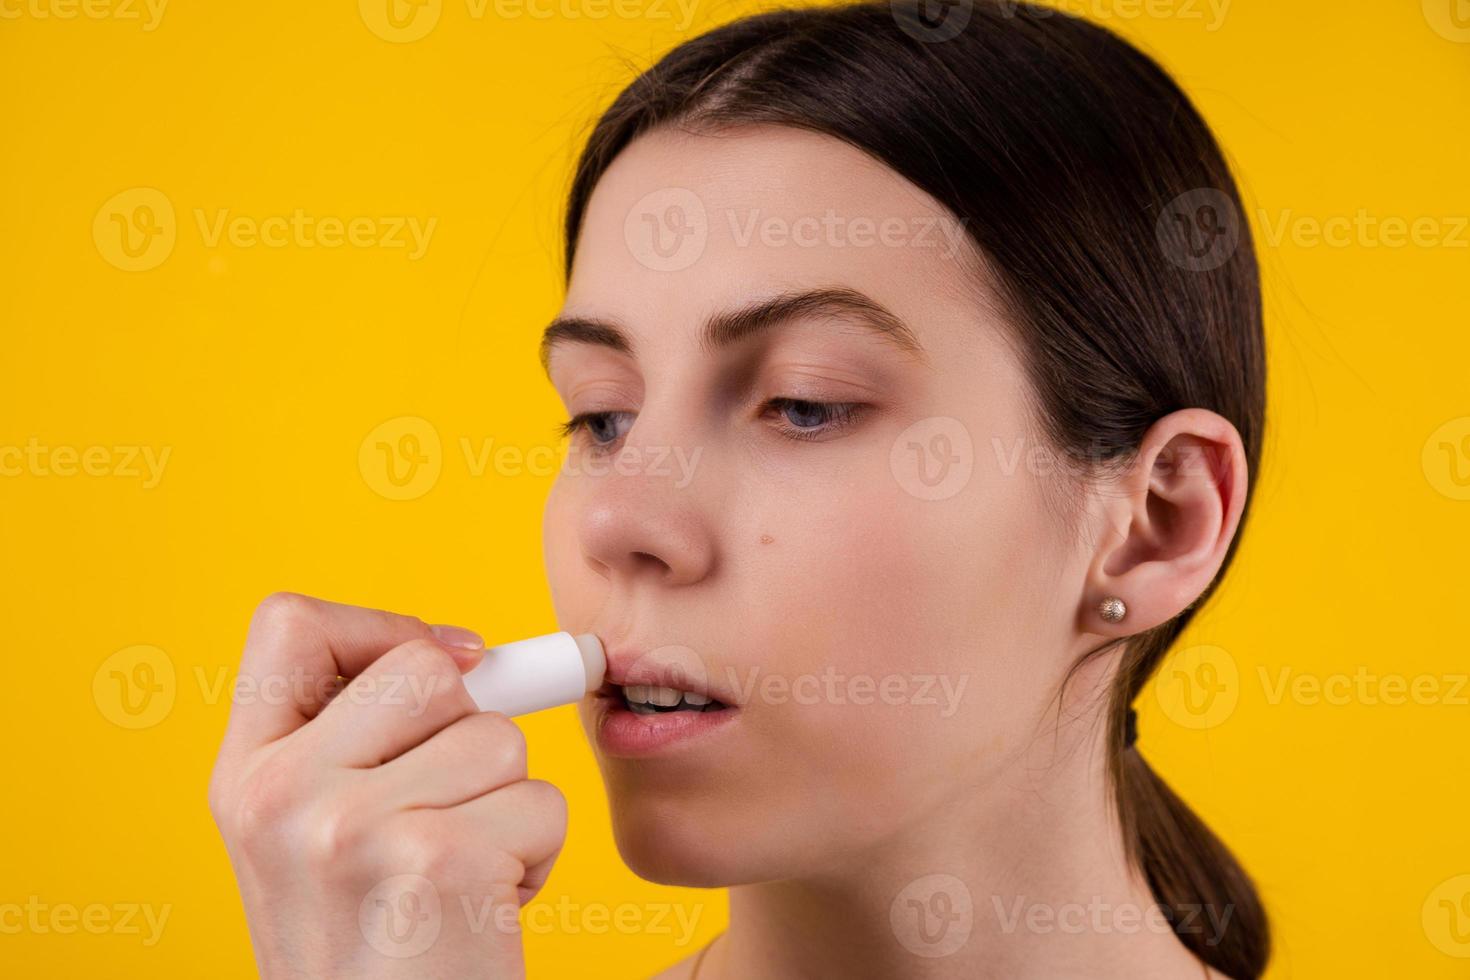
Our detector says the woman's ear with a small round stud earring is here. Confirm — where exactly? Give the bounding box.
[1080,408,1247,636]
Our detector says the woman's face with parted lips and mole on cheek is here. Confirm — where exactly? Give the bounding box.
[544,126,1086,886]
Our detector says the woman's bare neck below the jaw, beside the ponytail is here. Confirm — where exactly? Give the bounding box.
[700,725,1213,980]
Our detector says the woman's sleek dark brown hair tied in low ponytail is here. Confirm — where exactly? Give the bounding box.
[566,0,1270,980]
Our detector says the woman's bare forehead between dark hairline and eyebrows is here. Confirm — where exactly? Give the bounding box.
[564,126,978,357]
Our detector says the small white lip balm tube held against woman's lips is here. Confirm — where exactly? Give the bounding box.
[463,632,607,716]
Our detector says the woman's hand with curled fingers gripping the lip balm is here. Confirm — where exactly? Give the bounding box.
[209,594,566,979]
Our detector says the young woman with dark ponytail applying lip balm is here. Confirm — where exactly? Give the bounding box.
[210,0,1269,980]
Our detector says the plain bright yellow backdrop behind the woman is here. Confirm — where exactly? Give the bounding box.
[0,0,1470,979]
